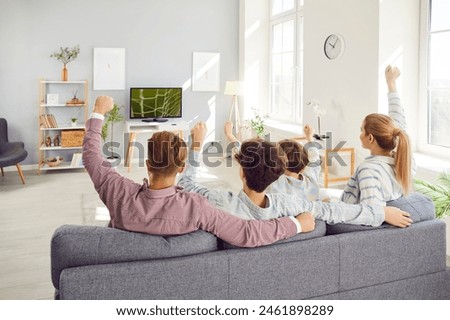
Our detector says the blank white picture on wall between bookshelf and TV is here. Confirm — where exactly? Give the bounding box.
[93,48,125,90]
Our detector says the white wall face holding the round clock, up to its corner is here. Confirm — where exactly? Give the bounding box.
[304,0,379,165]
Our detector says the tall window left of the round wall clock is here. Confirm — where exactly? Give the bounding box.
[269,0,303,122]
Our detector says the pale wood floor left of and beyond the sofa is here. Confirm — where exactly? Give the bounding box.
[0,162,450,299]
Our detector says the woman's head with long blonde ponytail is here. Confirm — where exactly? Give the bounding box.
[360,113,411,194]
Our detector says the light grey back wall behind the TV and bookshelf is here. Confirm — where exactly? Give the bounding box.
[0,0,239,164]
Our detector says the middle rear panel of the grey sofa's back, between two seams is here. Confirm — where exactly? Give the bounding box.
[227,232,339,300]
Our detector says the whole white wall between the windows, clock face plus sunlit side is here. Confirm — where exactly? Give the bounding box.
[304,0,420,163]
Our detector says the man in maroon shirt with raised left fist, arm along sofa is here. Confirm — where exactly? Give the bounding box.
[83,96,315,247]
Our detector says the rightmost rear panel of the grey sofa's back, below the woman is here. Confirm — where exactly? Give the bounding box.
[338,220,446,291]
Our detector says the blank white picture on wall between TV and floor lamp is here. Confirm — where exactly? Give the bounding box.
[192,52,220,91]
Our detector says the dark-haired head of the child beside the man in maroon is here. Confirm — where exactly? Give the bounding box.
[235,139,286,192]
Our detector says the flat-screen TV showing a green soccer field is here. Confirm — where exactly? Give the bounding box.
[130,88,182,121]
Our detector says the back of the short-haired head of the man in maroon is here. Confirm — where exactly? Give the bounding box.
[147,131,187,177]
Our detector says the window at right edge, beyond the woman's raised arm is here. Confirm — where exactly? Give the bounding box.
[422,0,450,154]
